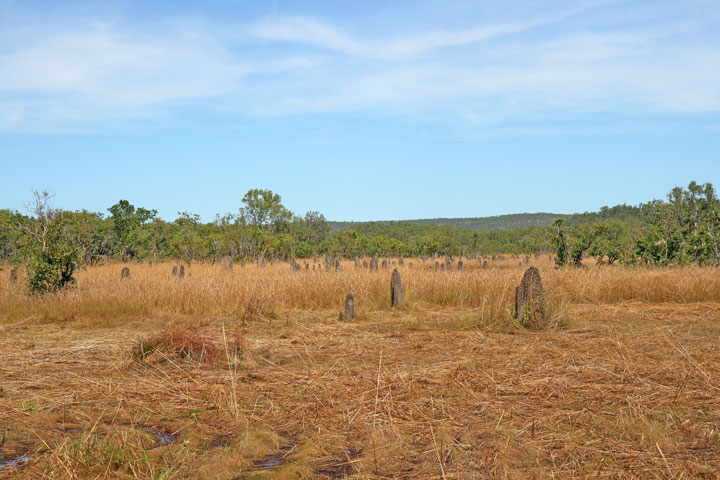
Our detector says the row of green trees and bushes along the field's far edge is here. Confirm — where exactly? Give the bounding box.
[0,182,720,291]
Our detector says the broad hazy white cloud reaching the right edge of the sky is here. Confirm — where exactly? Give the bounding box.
[258,34,720,116]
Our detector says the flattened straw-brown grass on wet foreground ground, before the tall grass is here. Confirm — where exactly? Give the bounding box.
[0,302,720,479]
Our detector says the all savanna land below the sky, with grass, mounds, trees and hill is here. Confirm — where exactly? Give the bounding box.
[0,182,720,480]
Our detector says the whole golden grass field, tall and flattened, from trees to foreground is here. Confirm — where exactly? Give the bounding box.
[0,255,720,480]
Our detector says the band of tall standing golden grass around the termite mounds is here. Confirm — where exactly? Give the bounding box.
[0,256,720,322]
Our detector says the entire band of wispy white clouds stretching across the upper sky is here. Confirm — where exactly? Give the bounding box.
[0,3,720,131]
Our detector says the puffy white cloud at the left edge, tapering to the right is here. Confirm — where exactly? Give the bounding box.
[0,24,316,131]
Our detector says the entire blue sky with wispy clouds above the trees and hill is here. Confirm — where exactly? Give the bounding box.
[0,0,720,221]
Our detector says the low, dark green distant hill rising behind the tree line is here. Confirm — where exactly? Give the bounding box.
[328,212,573,233]
